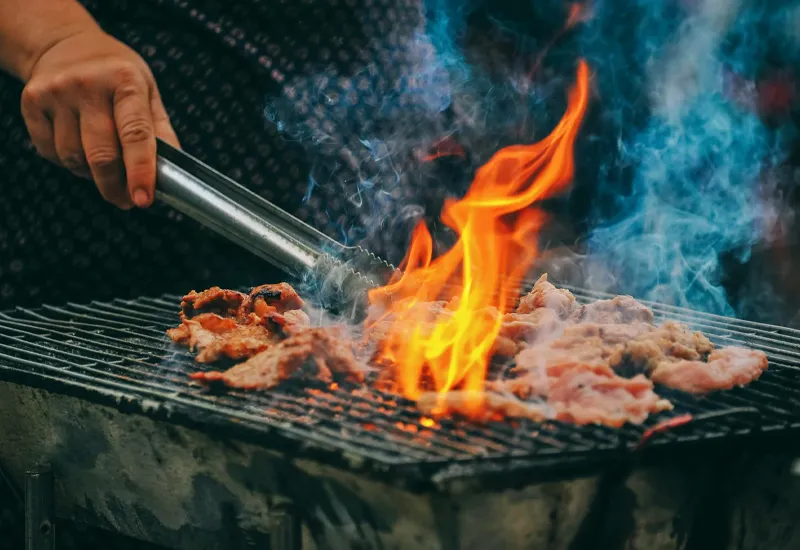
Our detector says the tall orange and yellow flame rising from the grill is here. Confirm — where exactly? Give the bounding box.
[369,60,589,414]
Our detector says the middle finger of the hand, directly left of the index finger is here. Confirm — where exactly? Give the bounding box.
[80,101,133,210]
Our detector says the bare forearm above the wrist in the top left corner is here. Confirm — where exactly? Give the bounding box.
[0,0,99,81]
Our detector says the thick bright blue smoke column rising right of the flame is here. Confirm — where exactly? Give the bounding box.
[582,0,797,315]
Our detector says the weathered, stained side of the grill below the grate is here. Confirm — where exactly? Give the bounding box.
[0,382,800,550]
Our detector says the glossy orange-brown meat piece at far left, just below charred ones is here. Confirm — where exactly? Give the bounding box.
[167,313,282,363]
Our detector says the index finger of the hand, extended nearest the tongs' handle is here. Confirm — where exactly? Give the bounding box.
[113,72,156,208]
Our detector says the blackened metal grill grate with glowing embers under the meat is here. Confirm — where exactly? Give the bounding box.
[0,289,800,483]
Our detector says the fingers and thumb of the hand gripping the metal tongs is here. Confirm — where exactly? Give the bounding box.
[22,63,180,209]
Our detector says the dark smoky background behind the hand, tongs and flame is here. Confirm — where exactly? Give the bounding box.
[0,0,800,324]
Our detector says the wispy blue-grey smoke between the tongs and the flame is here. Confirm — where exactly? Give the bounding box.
[265,0,575,262]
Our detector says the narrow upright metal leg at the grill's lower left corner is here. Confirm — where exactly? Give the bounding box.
[25,464,56,550]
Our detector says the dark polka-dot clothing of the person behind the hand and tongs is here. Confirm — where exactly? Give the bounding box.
[0,0,422,309]
